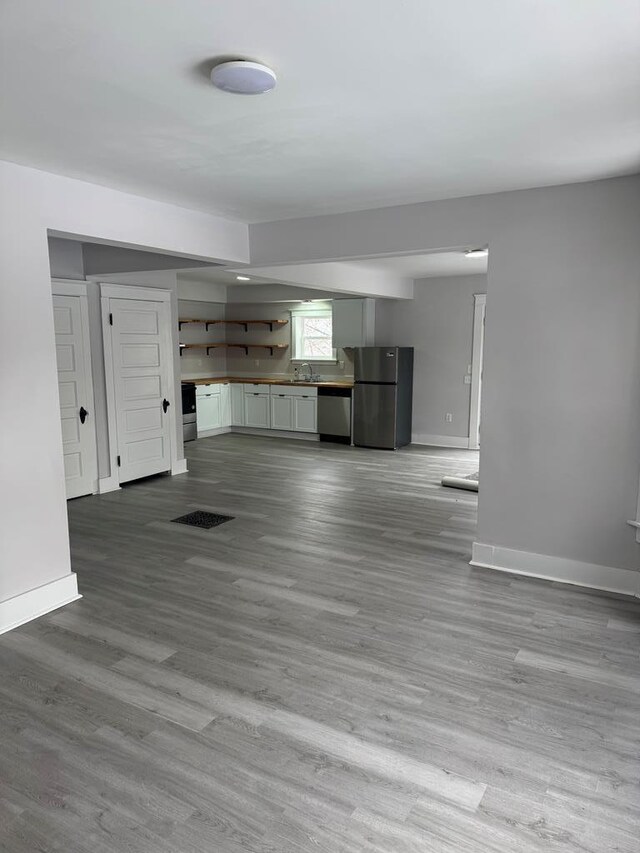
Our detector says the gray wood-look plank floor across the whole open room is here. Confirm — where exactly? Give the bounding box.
[0,435,640,853]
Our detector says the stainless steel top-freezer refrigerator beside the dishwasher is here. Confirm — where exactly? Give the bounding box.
[353,347,413,450]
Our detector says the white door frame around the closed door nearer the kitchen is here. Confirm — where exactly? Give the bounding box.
[100,283,180,491]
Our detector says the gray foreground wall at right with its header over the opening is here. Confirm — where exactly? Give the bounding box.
[250,176,640,570]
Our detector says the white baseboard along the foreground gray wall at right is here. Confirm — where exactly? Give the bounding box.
[471,542,640,597]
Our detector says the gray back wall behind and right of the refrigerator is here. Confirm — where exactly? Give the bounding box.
[376,275,487,443]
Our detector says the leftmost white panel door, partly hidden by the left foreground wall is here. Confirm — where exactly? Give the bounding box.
[53,296,96,498]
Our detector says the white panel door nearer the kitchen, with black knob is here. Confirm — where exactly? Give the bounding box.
[109,299,175,483]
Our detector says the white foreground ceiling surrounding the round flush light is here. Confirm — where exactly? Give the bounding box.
[0,0,640,222]
